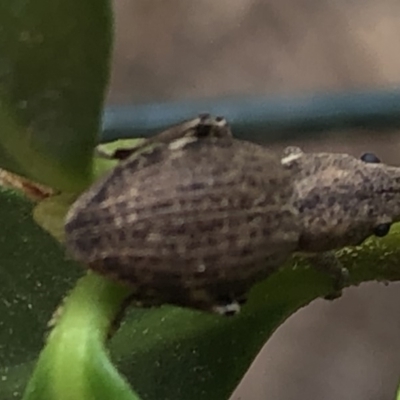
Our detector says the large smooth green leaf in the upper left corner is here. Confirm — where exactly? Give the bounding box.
[0,0,111,191]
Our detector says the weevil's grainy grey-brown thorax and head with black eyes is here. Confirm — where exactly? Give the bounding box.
[295,153,400,252]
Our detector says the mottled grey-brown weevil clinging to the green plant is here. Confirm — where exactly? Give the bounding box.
[65,115,400,315]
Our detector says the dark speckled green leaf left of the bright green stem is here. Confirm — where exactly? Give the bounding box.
[0,187,82,400]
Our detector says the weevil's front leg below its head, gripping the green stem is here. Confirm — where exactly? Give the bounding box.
[309,251,349,300]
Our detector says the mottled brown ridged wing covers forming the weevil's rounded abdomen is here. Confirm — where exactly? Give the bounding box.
[65,115,299,315]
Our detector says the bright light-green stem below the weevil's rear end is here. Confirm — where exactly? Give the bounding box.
[23,273,139,400]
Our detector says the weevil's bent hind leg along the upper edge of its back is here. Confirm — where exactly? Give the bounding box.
[97,114,232,160]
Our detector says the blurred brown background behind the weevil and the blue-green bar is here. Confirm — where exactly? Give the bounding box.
[109,0,400,400]
